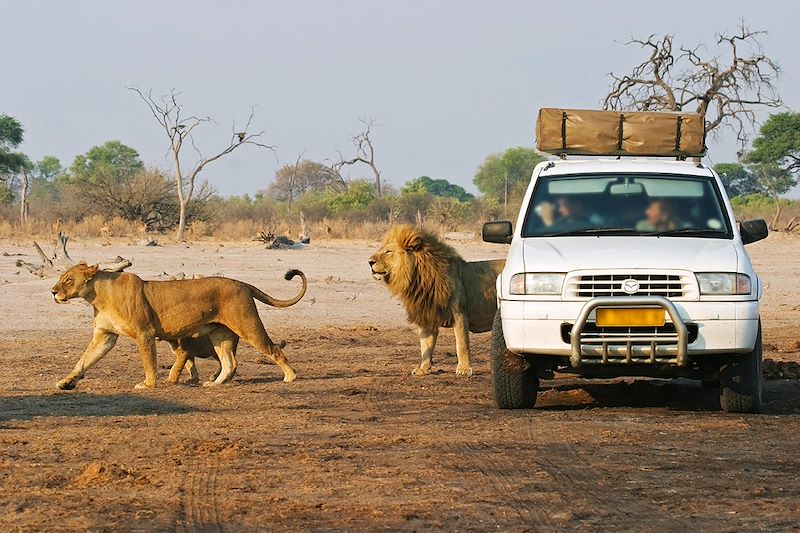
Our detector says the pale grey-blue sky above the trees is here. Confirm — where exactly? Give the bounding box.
[0,0,800,195]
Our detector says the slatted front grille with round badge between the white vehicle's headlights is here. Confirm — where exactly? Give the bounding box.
[565,272,697,299]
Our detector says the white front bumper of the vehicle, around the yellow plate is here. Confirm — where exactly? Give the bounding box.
[500,297,759,366]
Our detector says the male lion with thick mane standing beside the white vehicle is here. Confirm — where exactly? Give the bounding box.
[369,226,505,376]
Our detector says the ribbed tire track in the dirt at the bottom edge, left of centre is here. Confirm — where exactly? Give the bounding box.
[175,464,223,533]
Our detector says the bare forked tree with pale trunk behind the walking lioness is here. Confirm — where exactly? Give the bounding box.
[128,87,275,242]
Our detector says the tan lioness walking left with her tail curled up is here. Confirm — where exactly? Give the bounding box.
[52,262,308,389]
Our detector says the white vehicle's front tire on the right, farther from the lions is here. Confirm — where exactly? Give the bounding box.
[719,322,764,413]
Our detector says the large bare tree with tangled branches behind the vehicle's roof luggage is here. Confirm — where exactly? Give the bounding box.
[603,23,783,149]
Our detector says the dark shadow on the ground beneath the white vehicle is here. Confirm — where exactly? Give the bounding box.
[536,379,800,415]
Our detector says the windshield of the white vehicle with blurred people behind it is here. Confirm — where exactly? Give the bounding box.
[522,174,732,239]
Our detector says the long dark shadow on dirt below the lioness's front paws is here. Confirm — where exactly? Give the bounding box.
[0,393,197,422]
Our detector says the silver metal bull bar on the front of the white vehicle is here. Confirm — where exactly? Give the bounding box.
[570,296,689,367]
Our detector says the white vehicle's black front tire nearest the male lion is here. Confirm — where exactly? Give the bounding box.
[491,309,539,409]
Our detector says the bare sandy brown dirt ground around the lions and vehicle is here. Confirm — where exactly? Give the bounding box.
[0,235,800,531]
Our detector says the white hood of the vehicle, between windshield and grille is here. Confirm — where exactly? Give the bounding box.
[522,236,739,272]
